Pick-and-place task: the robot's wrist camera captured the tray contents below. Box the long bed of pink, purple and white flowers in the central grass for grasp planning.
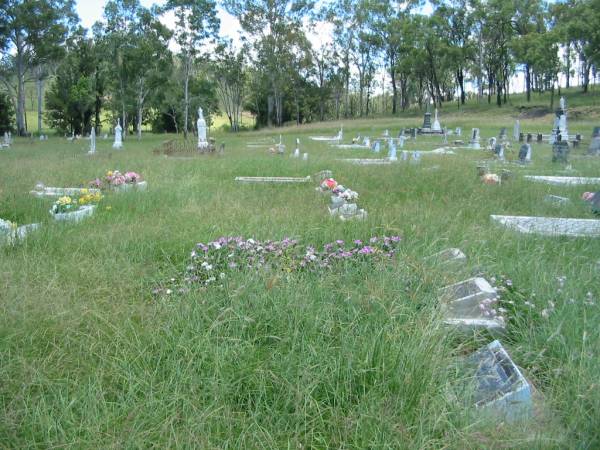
[154,236,401,294]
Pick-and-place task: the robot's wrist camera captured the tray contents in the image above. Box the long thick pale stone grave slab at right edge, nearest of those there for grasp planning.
[490,215,600,237]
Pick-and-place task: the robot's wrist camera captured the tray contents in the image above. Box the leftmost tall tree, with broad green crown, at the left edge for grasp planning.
[0,0,77,135]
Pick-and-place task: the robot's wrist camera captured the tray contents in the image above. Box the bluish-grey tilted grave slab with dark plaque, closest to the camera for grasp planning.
[461,340,533,422]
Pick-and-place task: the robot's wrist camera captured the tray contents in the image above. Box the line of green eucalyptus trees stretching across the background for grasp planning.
[0,0,600,136]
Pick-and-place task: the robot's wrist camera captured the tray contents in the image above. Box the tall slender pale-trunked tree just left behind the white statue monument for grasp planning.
[163,0,219,139]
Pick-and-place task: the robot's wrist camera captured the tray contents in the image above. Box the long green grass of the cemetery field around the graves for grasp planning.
[0,93,600,449]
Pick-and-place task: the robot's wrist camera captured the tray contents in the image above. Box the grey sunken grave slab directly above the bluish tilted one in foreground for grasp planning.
[440,277,505,331]
